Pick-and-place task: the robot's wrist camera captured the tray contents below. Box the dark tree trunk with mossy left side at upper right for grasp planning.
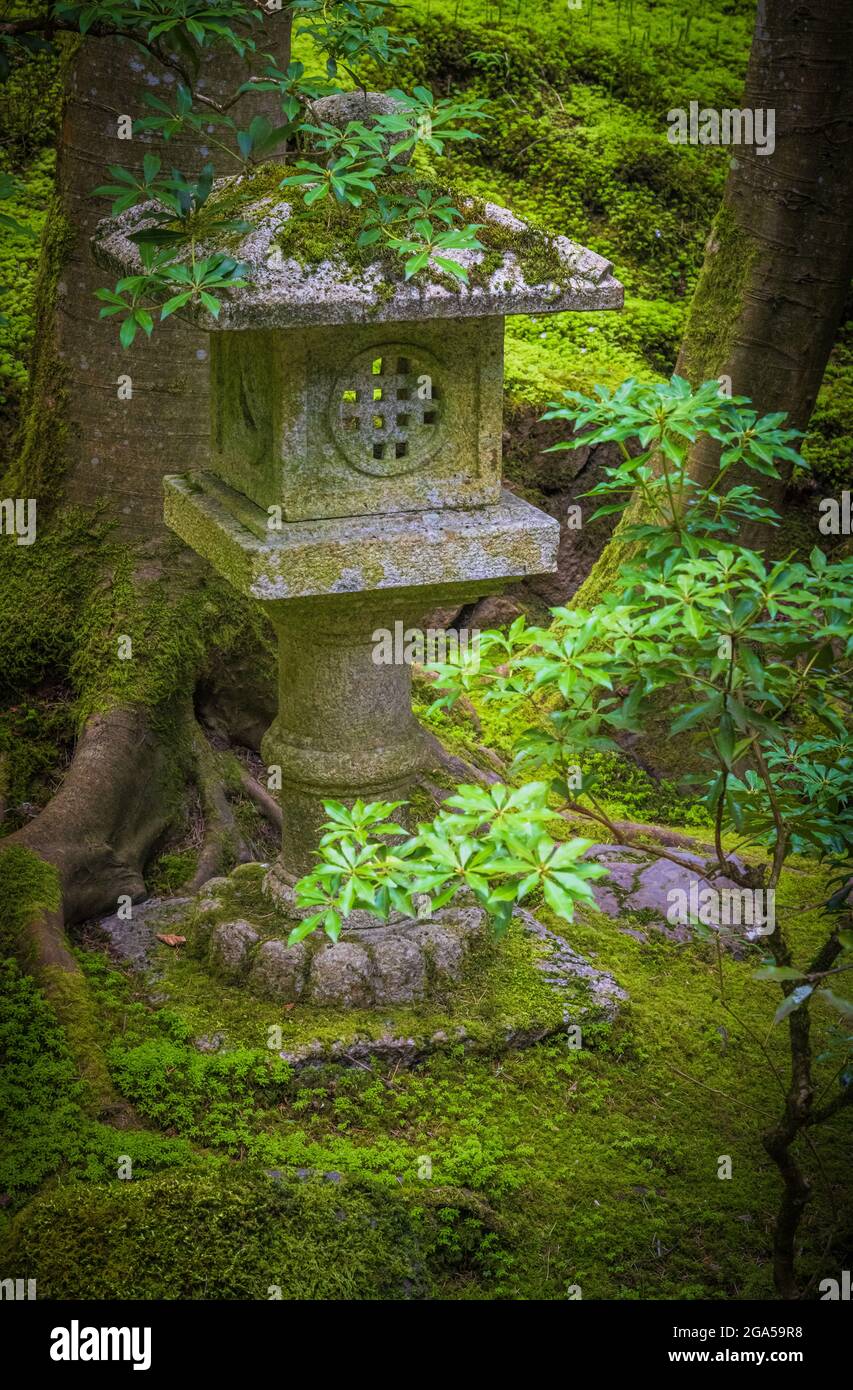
[675,0,853,507]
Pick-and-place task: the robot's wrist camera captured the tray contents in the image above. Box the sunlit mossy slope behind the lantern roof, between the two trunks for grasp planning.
[376,12,753,406]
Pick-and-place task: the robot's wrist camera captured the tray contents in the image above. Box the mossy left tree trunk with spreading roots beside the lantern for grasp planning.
[0,11,292,1089]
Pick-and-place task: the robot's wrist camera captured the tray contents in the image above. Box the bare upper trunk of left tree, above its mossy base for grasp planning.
[7,11,292,539]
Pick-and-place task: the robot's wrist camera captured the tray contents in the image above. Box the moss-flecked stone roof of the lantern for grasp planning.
[93,165,622,329]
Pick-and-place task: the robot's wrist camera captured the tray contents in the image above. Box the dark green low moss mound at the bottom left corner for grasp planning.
[4,1169,497,1301]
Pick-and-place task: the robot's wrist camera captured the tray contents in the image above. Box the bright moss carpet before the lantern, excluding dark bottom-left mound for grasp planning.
[28,863,849,1300]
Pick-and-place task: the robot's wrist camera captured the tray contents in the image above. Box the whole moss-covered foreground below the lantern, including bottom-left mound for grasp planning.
[0,839,852,1300]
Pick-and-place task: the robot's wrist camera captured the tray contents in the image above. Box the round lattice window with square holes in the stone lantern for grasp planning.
[340,356,440,461]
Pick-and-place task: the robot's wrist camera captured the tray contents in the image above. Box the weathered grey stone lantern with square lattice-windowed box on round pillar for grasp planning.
[94,200,622,900]
